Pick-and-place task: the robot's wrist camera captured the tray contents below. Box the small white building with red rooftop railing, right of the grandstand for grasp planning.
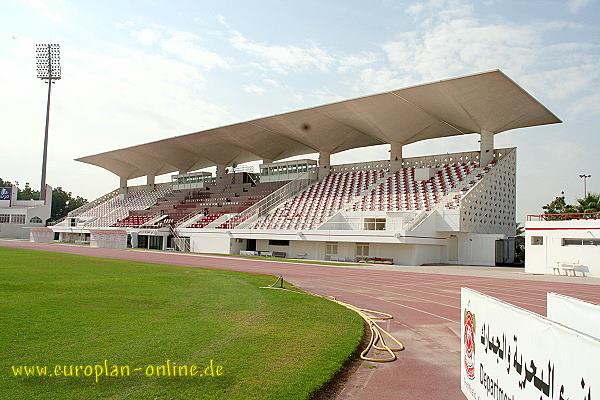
[525,213,600,277]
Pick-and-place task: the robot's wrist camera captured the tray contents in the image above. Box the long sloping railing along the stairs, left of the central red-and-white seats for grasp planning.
[221,172,314,229]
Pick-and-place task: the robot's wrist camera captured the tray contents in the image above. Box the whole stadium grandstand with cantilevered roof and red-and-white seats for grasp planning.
[44,70,561,265]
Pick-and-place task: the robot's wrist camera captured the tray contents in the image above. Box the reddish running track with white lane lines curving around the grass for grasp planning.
[0,240,600,400]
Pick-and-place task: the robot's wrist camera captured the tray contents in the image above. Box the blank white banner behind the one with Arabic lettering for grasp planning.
[546,293,600,340]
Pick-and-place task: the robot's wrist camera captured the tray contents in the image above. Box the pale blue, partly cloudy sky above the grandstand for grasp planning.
[0,0,600,221]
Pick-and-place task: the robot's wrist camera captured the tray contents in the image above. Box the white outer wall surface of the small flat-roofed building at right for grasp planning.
[525,220,600,276]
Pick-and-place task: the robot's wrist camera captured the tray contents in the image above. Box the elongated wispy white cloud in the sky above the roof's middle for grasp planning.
[229,30,334,74]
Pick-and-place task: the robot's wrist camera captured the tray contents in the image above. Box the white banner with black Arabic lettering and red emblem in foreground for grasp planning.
[460,288,600,400]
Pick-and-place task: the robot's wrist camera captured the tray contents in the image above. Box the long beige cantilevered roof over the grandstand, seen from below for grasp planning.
[77,70,561,179]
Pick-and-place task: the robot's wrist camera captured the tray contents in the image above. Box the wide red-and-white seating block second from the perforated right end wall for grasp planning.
[352,162,476,211]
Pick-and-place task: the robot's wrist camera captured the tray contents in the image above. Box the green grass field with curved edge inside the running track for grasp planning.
[0,248,363,399]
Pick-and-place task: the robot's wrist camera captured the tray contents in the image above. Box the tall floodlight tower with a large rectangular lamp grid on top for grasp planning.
[35,43,60,200]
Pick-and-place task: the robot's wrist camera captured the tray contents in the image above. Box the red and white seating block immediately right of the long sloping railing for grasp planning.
[254,170,385,229]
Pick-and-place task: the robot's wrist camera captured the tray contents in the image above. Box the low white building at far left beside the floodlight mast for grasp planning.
[0,185,52,239]
